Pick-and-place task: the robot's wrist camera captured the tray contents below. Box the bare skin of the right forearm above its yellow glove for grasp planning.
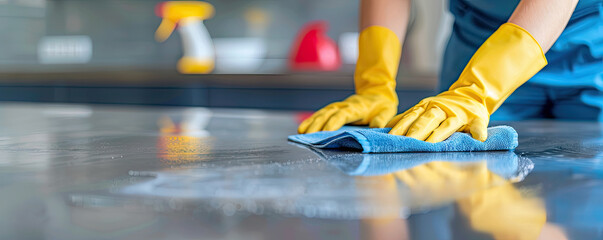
[509,0,578,53]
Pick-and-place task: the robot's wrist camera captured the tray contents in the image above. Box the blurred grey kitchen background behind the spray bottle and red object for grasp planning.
[0,0,452,110]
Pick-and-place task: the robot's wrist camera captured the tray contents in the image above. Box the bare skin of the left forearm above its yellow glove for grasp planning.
[360,0,410,41]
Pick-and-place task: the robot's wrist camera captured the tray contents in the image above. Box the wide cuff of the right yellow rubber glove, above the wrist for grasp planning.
[449,23,547,114]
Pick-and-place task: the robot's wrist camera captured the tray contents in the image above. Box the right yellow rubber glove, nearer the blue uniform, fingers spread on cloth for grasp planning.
[387,23,547,142]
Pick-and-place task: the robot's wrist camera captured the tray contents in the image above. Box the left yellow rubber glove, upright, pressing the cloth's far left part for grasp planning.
[297,26,402,133]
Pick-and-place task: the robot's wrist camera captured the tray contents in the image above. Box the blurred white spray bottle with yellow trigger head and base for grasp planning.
[155,1,215,74]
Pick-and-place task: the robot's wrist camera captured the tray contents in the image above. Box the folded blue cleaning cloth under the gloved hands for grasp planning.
[289,126,517,153]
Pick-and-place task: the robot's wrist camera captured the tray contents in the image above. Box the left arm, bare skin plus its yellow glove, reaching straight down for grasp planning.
[297,0,410,133]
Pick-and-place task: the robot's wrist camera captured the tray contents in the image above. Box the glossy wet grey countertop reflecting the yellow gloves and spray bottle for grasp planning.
[0,103,603,239]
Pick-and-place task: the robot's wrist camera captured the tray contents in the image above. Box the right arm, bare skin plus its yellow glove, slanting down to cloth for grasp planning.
[386,0,577,142]
